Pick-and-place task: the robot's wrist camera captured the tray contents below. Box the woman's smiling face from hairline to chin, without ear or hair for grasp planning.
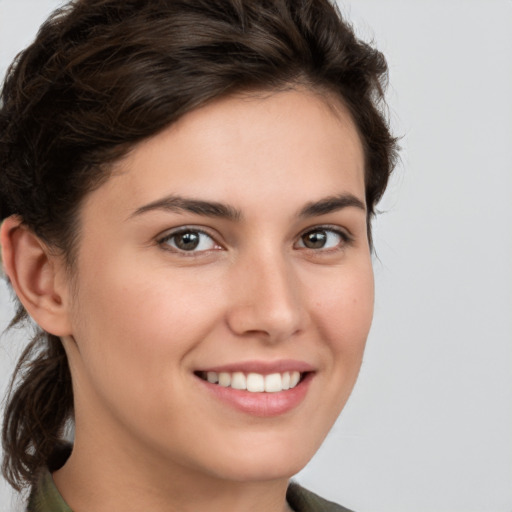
[65,91,373,481]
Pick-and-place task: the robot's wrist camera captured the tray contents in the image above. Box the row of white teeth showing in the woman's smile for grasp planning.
[201,371,301,393]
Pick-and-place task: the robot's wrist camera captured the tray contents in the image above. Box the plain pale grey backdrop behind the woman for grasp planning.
[0,0,512,512]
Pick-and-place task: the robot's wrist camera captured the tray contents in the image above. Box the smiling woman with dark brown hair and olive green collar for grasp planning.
[0,0,395,512]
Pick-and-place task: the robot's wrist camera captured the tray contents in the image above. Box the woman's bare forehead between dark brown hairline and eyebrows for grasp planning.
[84,90,364,220]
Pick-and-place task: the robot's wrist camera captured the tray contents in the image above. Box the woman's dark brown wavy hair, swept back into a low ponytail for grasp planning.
[0,0,396,489]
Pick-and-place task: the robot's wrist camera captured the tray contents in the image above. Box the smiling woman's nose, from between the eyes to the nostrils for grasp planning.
[227,249,308,343]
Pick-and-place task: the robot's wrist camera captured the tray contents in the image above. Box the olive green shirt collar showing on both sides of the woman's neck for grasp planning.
[27,470,350,512]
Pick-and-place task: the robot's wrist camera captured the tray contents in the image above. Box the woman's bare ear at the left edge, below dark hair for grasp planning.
[0,215,71,336]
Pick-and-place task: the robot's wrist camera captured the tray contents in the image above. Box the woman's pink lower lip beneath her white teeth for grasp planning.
[197,372,314,417]
